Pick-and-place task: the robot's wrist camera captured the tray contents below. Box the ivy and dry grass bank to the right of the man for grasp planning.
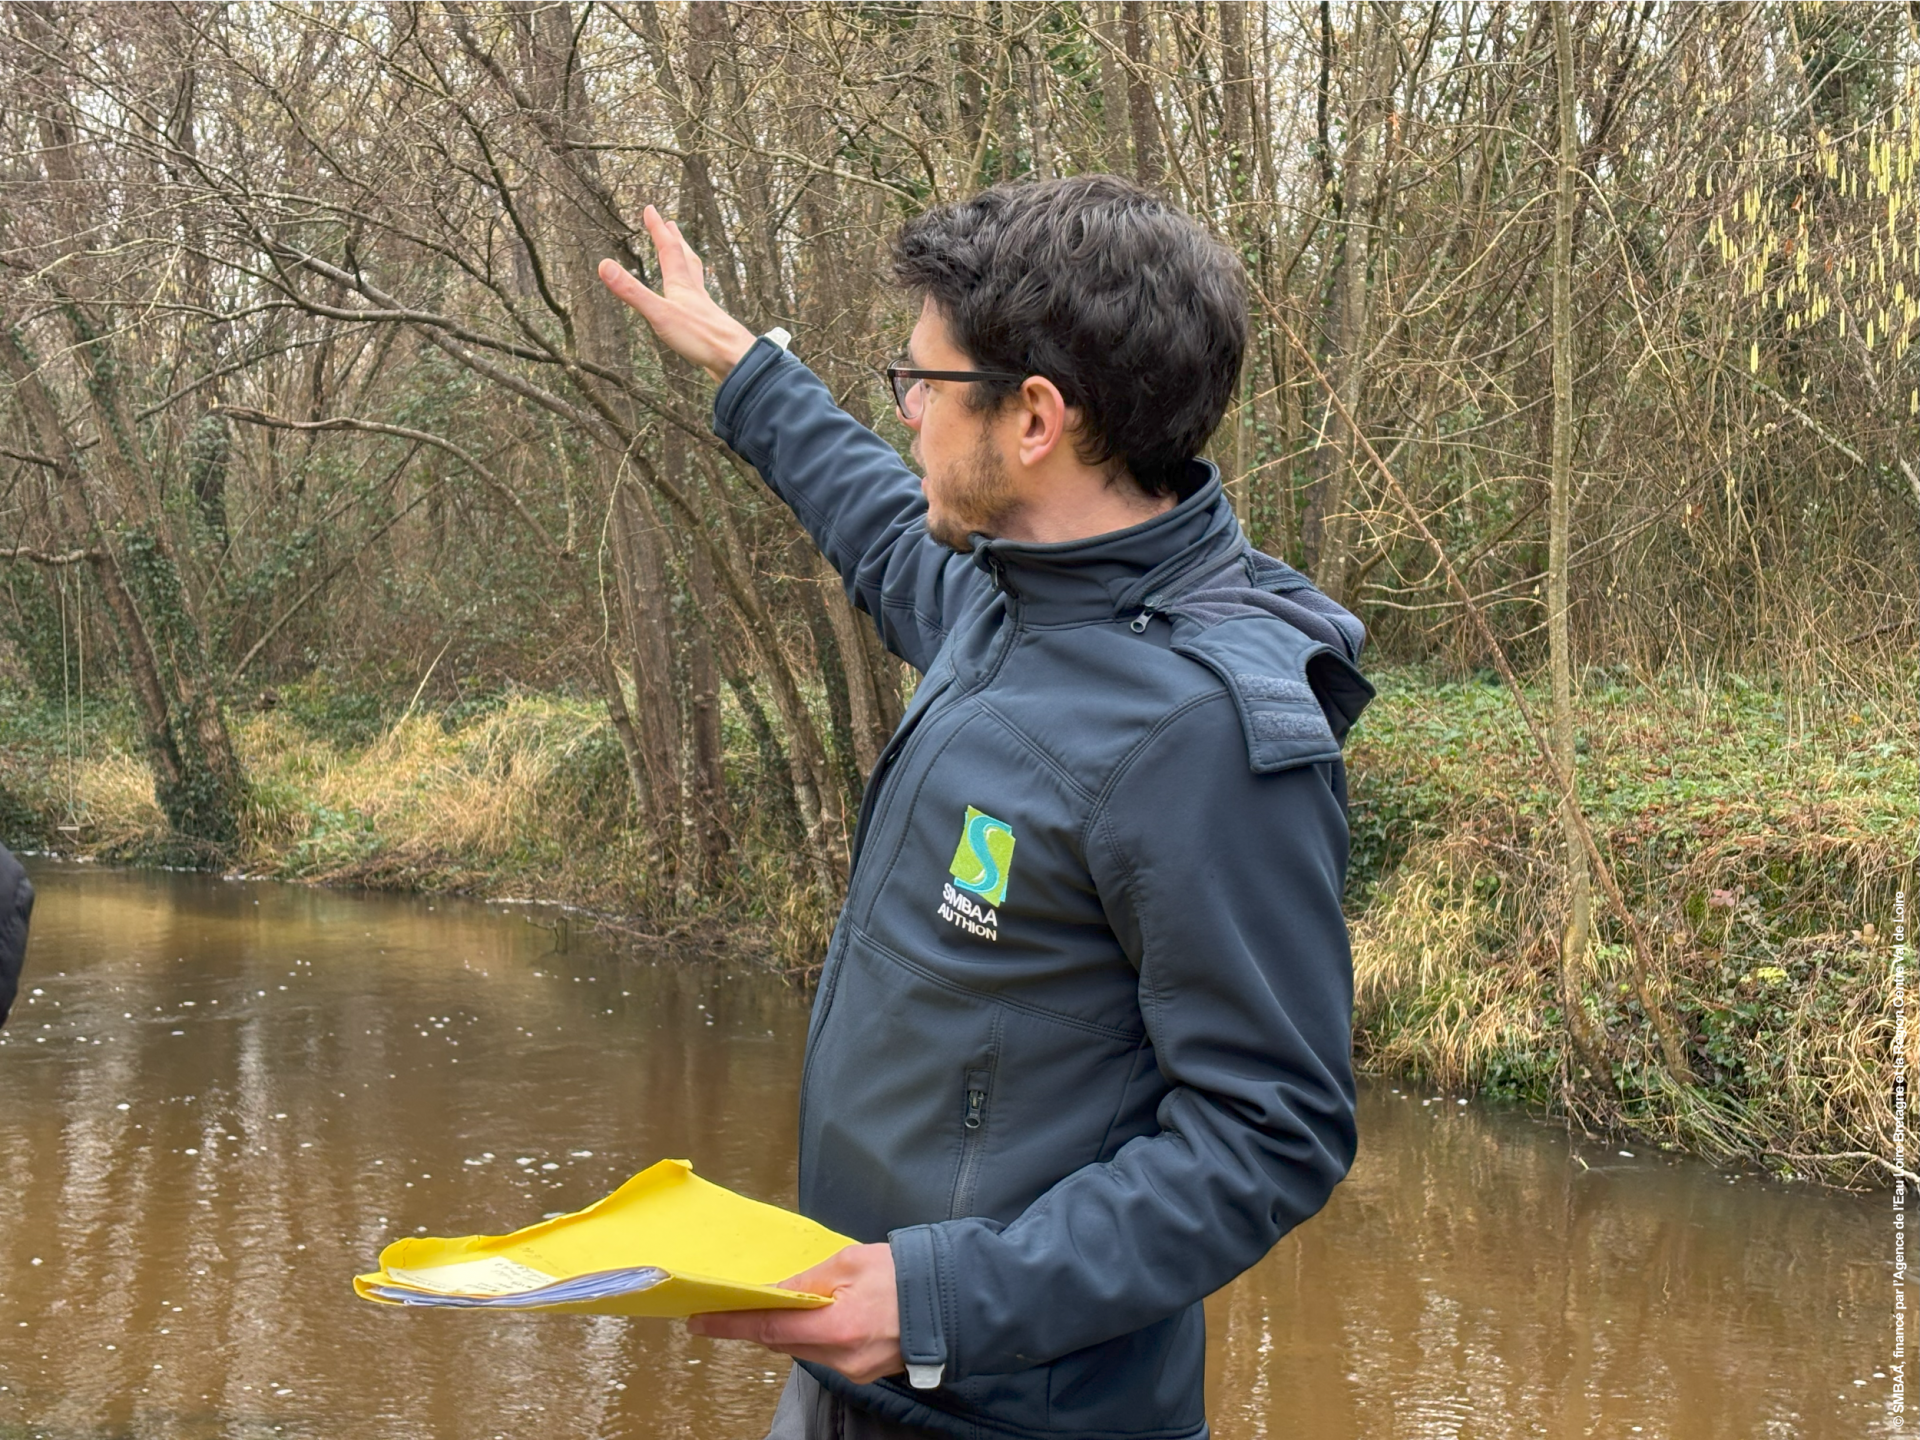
[1350,670,1920,1183]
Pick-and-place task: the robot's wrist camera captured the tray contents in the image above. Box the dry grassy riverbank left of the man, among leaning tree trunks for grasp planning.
[0,684,822,964]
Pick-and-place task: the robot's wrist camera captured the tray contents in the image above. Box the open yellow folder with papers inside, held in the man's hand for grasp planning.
[353,1160,852,1317]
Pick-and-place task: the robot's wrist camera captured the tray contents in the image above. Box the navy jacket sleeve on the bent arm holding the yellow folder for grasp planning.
[891,693,1356,1380]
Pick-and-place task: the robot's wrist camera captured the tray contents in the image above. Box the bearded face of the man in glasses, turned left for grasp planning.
[906,300,1023,553]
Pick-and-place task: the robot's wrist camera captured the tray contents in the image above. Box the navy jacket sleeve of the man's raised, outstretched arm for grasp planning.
[714,340,987,670]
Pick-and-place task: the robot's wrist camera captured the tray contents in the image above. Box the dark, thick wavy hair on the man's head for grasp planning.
[893,175,1246,497]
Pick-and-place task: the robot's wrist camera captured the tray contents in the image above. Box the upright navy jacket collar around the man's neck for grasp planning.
[972,461,1246,624]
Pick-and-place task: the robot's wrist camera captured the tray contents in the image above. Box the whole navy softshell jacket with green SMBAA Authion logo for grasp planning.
[714,340,1373,1440]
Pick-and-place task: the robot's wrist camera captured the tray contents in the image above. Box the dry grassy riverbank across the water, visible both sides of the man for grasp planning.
[0,670,1920,1185]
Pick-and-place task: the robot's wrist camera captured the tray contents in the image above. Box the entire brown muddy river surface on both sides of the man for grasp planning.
[0,864,1907,1440]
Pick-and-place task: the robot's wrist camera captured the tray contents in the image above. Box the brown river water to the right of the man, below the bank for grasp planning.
[1210,1085,1907,1440]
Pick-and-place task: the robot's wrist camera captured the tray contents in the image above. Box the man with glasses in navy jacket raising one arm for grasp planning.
[601,177,1373,1440]
